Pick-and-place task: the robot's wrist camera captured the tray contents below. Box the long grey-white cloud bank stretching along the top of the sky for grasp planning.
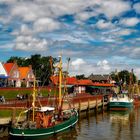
[5,0,131,22]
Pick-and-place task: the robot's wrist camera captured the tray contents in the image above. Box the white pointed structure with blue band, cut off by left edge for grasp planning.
[0,62,8,87]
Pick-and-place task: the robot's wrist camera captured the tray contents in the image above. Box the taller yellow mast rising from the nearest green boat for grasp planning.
[58,56,62,107]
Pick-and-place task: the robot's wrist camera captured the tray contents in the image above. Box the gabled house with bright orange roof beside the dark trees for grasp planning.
[18,65,35,87]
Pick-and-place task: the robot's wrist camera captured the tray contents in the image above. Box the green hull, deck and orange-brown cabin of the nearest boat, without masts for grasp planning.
[10,107,78,139]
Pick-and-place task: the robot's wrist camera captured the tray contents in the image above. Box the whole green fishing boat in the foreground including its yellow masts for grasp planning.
[10,57,78,139]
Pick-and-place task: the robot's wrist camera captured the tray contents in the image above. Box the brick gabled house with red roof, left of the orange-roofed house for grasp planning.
[3,62,21,87]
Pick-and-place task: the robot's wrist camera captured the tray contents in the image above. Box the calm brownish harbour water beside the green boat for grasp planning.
[0,108,140,140]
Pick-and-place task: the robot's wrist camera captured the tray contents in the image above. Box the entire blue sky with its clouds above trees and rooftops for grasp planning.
[0,0,140,78]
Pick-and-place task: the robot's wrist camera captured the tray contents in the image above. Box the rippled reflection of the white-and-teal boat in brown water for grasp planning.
[110,110,135,140]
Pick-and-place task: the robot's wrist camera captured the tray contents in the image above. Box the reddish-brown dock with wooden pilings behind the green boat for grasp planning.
[0,94,108,125]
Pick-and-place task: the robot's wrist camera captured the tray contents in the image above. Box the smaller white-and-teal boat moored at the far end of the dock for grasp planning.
[109,93,133,110]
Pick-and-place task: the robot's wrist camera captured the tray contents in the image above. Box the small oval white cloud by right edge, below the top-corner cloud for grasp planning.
[120,17,140,26]
